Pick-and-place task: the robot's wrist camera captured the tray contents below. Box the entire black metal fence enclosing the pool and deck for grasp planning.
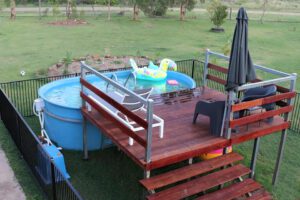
[0,59,300,199]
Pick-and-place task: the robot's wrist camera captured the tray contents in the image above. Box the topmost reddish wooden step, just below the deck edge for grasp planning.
[140,153,243,190]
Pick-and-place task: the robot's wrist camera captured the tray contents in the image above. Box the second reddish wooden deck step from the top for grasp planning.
[147,164,251,200]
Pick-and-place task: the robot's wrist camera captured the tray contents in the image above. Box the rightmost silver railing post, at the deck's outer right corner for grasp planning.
[272,73,297,185]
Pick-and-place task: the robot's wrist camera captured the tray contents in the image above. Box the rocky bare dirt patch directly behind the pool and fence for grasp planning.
[47,55,149,76]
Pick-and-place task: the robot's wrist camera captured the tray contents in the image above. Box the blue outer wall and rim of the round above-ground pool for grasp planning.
[38,70,196,150]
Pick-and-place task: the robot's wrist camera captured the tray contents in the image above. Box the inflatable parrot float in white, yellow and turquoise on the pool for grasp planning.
[130,58,177,81]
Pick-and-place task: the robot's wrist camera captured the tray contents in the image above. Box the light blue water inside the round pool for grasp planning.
[45,71,191,108]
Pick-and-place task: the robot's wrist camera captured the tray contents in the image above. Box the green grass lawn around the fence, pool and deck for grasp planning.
[0,13,300,200]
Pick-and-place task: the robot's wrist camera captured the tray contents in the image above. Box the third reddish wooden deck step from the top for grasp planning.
[196,179,262,200]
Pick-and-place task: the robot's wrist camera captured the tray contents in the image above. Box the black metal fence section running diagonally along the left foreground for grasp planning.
[0,89,82,200]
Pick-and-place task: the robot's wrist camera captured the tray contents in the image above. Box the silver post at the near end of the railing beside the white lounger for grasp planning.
[145,99,153,163]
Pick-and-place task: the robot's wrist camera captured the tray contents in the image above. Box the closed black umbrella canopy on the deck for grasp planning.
[225,8,256,91]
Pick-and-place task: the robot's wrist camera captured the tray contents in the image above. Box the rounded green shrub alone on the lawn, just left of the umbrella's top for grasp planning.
[207,0,227,28]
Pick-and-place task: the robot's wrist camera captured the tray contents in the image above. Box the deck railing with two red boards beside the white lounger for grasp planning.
[80,62,153,163]
